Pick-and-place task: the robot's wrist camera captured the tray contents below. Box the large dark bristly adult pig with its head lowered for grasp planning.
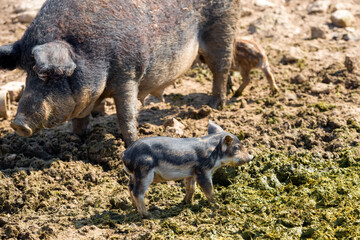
[0,0,240,145]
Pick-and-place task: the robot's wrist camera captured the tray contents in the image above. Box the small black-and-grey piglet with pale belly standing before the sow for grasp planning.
[122,121,253,217]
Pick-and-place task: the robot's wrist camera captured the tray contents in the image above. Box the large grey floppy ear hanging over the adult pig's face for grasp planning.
[32,41,76,80]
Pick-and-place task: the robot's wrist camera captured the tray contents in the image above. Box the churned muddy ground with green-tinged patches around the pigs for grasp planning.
[0,0,360,239]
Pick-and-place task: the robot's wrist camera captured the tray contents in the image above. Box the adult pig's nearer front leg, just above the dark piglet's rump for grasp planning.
[114,80,138,147]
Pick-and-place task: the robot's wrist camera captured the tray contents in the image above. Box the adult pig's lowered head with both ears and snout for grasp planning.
[0,41,100,136]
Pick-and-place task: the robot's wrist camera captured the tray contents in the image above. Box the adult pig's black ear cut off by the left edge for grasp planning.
[0,43,20,70]
